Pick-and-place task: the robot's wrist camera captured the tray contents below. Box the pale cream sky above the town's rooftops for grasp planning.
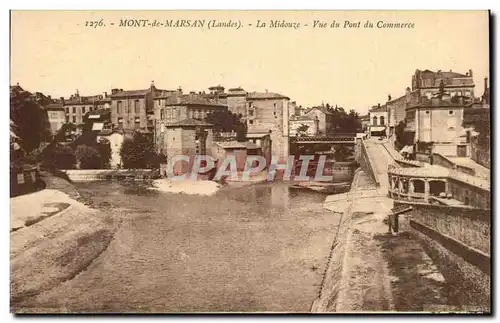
[10,11,489,113]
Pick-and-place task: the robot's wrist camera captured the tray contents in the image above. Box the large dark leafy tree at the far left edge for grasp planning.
[10,87,50,152]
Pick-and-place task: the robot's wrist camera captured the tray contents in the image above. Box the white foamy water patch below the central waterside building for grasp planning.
[146,178,221,196]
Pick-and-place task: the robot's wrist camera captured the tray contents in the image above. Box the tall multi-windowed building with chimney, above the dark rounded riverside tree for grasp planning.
[111,83,165,133]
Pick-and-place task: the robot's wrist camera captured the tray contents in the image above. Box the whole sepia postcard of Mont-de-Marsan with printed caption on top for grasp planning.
[10,10,492,314]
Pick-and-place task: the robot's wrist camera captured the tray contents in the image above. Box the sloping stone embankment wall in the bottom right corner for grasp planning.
[394,201,491,310]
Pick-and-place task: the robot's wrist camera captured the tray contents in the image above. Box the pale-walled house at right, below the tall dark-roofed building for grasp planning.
[406,96,471,161]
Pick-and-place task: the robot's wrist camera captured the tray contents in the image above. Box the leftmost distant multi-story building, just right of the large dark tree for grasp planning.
[60,90,111,125]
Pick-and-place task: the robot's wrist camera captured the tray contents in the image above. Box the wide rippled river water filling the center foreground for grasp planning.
[29,182,346,313]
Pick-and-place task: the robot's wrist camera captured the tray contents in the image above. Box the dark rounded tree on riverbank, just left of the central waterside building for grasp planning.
[120,132,160,169]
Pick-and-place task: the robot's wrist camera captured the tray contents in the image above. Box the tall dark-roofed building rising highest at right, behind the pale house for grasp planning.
[412,70,475,99]
